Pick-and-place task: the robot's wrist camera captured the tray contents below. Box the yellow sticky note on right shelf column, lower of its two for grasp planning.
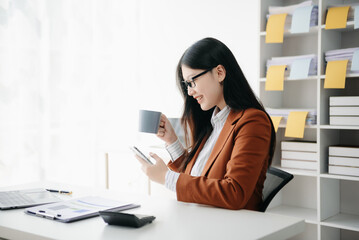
[324,60,348,88]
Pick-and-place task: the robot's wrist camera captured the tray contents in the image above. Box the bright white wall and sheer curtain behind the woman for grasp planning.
[0,0,259,190]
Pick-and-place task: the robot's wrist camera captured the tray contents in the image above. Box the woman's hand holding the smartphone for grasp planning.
[135,153,168,184]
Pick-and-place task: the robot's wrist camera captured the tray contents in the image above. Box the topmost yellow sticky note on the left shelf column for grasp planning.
[266,13,287,43]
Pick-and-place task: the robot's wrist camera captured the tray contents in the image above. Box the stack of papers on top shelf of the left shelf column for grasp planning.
[267,1,318,30]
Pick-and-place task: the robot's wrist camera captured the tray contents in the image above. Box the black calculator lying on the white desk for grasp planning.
[100,211,156,228]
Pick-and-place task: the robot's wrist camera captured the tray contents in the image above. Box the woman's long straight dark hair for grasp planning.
[177,38,276,170]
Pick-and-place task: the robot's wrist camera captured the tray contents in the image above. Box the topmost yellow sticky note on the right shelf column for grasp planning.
[325,6,350,29]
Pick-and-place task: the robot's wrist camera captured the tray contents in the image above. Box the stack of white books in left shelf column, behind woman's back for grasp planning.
[281,141,318,170]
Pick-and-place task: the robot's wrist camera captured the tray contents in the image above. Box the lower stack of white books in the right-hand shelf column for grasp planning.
[328,146,359,176]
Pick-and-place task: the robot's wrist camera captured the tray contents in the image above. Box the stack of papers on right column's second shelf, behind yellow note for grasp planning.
[325,47,359,73]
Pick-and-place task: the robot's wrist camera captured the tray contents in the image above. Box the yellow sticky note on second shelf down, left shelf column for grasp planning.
[265,65,286,91]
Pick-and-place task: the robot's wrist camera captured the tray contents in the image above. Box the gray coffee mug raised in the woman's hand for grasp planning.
[138,110,161,134]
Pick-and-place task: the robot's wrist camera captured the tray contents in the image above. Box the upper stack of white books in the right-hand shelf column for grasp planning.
[329,96,359,126]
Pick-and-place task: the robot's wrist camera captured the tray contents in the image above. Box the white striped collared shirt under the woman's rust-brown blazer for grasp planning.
[165,106,231,191]
